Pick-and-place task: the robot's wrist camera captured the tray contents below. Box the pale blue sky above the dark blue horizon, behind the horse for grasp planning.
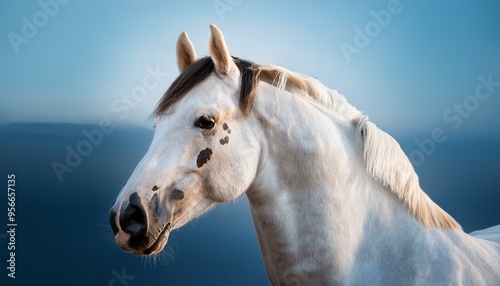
[0,0,500,139]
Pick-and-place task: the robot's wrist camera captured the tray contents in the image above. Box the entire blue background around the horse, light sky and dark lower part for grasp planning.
[0,0,500,285]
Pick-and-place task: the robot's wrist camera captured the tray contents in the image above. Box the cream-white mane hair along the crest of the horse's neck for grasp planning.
[257,65,460,228]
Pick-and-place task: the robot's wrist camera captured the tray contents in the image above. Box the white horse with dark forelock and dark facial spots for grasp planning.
[109,25,500,285]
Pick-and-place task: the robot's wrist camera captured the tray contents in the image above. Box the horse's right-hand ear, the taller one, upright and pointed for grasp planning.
[210,24,236,75]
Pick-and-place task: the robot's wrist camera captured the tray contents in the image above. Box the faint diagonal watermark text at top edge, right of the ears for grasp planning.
[339,0,403,63]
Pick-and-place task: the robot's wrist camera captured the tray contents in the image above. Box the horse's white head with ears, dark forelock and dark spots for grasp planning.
[109,25,260,255]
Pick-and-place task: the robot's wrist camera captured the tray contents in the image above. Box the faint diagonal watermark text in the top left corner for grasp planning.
[7,0,70,54]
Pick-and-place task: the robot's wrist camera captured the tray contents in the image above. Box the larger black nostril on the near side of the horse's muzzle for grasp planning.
[120,193,148,238]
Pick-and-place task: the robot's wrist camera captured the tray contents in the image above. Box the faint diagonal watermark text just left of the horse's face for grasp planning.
[51,66,168,183]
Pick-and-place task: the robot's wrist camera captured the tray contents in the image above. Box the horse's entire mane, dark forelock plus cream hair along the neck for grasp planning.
[154,54,460,228]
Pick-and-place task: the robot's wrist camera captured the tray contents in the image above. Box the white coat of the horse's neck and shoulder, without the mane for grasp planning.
[247,81,500,285]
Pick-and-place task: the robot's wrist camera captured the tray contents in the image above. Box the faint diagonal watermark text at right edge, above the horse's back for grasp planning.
[409,74,500,166]
